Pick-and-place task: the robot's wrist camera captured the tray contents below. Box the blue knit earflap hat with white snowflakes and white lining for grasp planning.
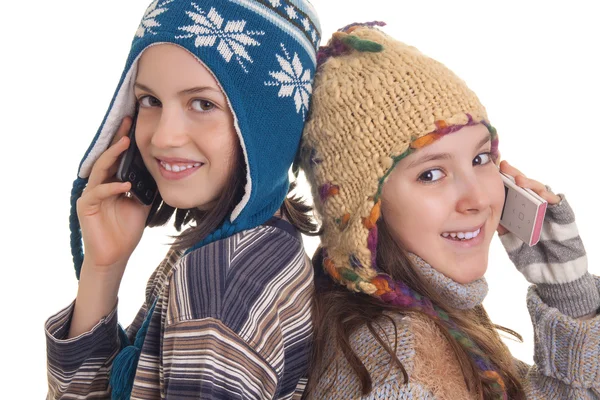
[70,0,321,278]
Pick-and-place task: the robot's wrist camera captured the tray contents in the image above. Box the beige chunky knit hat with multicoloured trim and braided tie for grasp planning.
[300,22,504,398]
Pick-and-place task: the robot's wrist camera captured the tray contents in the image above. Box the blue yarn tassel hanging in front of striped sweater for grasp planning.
[109,299,158,400]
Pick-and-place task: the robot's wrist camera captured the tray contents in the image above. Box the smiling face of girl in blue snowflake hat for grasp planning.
[135,44,241,210]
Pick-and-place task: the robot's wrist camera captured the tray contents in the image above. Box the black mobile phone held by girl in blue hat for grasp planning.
[117,105,158,205]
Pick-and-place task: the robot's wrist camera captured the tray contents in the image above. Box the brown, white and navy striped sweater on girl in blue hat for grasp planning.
[46,218,313,400]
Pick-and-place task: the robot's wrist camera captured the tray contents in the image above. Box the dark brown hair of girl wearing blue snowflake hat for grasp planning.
[146,144,317,245]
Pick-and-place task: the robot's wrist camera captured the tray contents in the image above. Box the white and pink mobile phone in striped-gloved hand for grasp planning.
[500,172,548,246]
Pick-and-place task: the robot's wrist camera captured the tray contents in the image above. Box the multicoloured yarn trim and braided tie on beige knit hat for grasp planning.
[306,21,507,400]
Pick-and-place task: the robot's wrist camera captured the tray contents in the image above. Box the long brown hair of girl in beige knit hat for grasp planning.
[305,218,525,399]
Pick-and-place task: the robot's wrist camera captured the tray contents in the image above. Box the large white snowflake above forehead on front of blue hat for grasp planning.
[175,3,265,73]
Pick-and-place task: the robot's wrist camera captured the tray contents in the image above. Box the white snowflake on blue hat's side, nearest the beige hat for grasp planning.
[265,43,312,120]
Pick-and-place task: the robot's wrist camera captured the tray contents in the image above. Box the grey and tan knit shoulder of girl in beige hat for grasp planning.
[317,313,470,399]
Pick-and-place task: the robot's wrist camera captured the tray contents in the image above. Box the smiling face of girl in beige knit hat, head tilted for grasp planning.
[381,124,504,283]
